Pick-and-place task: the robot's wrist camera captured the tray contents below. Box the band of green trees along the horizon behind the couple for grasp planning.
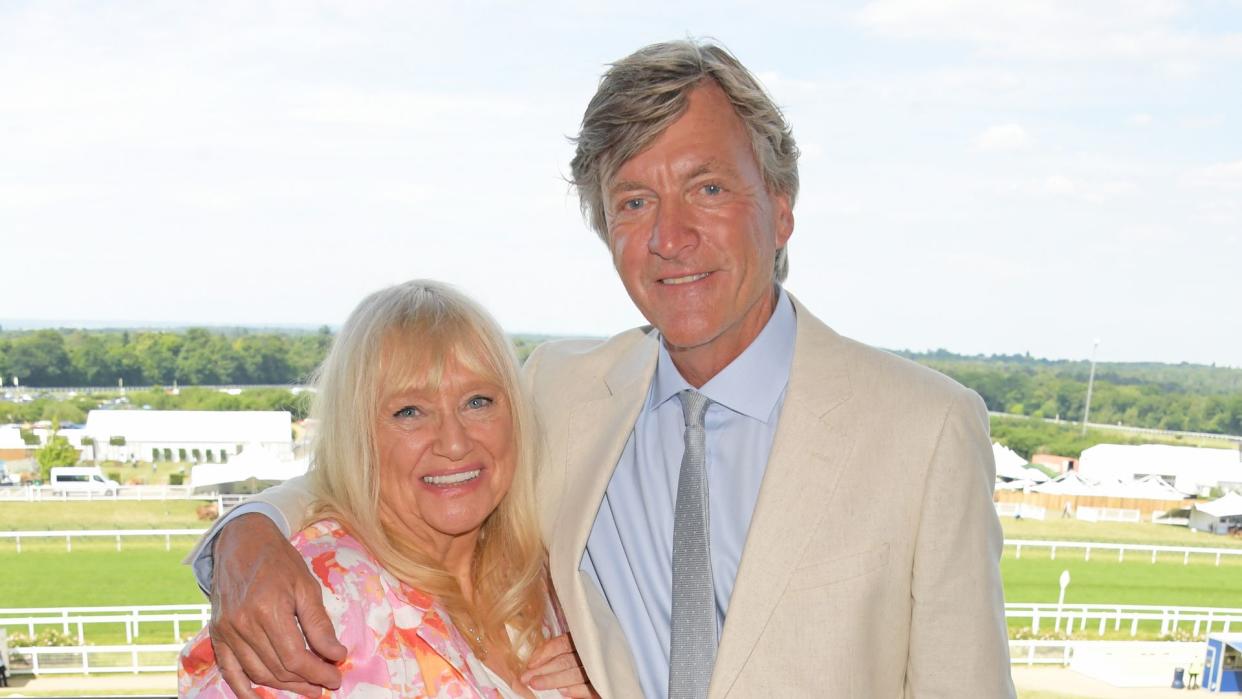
[0,327,1242,435]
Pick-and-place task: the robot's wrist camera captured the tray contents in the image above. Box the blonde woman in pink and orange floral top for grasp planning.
[179,281,586,698]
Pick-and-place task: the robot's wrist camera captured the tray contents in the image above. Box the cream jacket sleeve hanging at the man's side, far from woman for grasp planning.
[905,391,1015,698]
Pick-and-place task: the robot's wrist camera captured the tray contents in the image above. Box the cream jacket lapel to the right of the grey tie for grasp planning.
[710,299,853,697]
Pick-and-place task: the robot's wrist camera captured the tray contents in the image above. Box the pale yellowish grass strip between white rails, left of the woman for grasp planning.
[0,500,211,533]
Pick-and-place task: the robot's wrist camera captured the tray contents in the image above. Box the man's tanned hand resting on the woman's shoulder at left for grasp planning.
[211,514,345,699]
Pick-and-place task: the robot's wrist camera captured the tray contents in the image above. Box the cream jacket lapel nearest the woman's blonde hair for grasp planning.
[548,336,657,687]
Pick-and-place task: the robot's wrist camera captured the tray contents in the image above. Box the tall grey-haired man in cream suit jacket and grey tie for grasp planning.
[191,41,1013,698]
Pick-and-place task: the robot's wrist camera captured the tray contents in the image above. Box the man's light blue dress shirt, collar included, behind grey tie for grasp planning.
[581,289,797,699]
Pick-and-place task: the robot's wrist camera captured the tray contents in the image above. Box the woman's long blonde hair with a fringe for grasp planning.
[311,279,546,668]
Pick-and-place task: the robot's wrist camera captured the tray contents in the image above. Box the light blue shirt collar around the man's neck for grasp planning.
[647,287,797,422]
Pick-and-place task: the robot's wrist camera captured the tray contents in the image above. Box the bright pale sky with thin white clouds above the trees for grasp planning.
[0,0,1242,366]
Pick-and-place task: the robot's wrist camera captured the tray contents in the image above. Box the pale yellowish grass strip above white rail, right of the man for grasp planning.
[1001,516,1242,548]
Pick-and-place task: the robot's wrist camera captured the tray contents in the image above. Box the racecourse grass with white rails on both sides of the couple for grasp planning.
[0,500,1242,644]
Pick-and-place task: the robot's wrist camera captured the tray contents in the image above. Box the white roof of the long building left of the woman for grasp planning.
[86,410,293,444]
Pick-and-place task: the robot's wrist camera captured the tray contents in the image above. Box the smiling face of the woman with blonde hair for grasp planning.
[375,361,517,555]
